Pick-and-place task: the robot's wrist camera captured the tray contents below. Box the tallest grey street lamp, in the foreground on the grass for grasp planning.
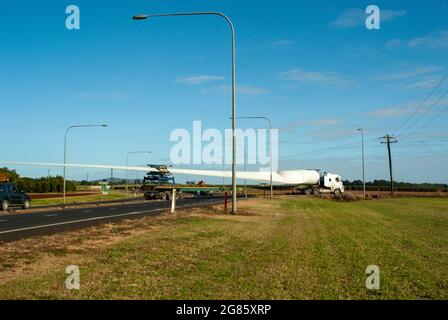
[132,12,237,214]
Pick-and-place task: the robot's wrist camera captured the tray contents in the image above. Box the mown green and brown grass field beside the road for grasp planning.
[0,197,448,299]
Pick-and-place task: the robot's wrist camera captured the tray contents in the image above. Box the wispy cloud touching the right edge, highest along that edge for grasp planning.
[386,30,448,49]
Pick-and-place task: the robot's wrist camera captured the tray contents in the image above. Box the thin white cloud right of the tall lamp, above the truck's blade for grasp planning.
[280,69,356,86]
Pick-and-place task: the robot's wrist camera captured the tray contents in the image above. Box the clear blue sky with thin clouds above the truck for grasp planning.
[0,0,448,183]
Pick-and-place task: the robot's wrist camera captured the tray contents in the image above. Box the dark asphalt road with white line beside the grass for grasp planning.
[0,197,230,242]
